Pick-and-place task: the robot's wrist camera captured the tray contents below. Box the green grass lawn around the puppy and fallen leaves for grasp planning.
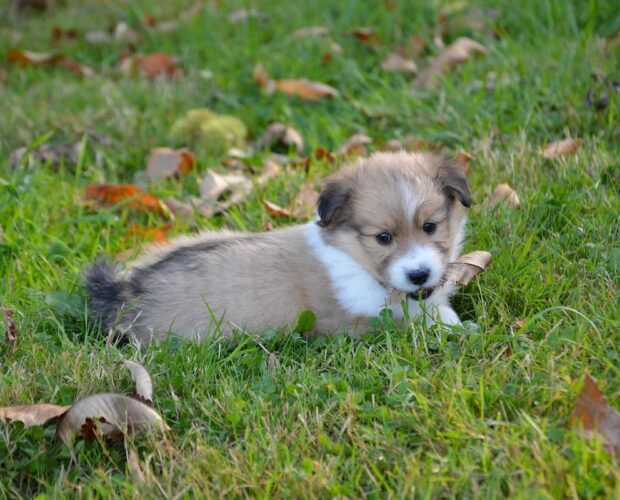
[0,0,620,498]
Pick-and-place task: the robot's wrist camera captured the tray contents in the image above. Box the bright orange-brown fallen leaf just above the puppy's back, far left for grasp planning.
[83,184,169,215]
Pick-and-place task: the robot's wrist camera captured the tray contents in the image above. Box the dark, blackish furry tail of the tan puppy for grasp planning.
[84,260,130,330]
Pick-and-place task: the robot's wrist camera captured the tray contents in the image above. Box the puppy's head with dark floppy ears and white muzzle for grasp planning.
[317,152,472,293]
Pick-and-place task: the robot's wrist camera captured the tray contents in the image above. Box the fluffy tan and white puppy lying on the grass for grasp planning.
[86,152,472,341]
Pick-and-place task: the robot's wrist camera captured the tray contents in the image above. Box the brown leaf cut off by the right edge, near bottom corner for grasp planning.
[571,372,620,455]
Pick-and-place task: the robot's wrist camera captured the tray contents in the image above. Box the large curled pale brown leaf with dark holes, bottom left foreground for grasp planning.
[56,393,167,444]
